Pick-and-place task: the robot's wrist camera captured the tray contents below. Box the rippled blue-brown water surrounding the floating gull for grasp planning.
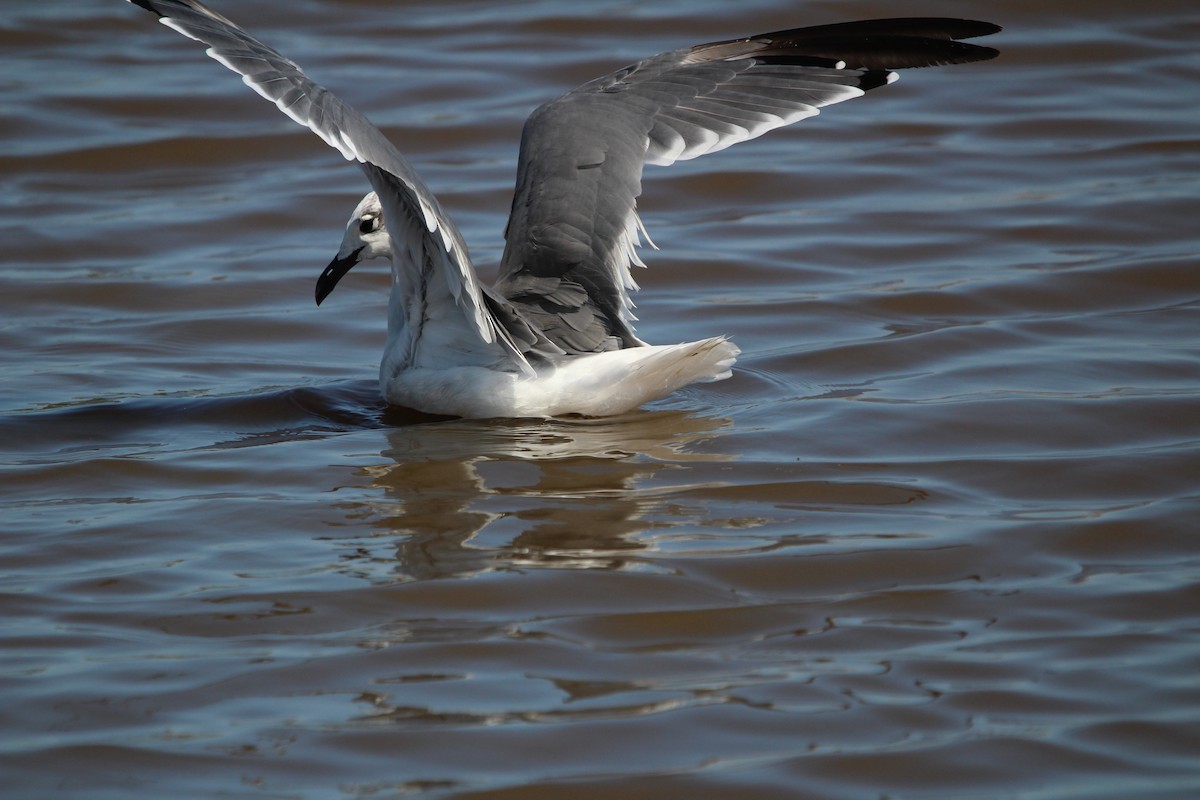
[0,0,1200,800]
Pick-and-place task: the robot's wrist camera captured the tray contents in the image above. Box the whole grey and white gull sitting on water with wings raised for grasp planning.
[130,0,1000,419]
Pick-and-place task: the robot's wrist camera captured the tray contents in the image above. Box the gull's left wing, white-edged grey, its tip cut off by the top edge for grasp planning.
[130,0,540,371]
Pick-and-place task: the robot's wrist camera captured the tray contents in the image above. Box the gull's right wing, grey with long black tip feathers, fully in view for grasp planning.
[494,18,1000,353]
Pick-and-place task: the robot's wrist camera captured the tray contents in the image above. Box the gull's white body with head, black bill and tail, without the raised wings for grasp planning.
[328,192,738,417]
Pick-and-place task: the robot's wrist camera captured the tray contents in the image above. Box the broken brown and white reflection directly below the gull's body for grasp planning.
[360,413,730,578]
